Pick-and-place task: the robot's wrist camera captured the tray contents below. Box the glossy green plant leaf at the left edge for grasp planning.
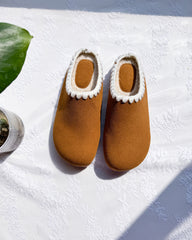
[0,23,33,93]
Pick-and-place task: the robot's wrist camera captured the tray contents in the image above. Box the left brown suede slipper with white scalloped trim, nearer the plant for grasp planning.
[53,50,103,167]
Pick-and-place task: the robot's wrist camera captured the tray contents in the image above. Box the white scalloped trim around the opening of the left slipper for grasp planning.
[66,49,103,99]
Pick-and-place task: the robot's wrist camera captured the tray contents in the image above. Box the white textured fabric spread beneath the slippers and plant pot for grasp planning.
[0,0,192,240]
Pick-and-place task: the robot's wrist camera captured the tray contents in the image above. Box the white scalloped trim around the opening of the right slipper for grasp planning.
[110,54,145,103]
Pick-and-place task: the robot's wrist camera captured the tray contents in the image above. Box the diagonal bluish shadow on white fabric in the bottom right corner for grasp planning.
[118,165,192,240]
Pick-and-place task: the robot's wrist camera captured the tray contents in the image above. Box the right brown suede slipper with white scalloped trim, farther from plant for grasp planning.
[103,54,150,171]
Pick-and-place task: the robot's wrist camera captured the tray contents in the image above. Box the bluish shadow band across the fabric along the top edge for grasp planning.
[0,0,192,17]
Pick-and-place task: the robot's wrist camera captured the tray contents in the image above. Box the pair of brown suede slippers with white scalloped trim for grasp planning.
[53,49,150,171]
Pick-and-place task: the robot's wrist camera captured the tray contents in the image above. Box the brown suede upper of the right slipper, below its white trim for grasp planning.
[103,88,150,171]
